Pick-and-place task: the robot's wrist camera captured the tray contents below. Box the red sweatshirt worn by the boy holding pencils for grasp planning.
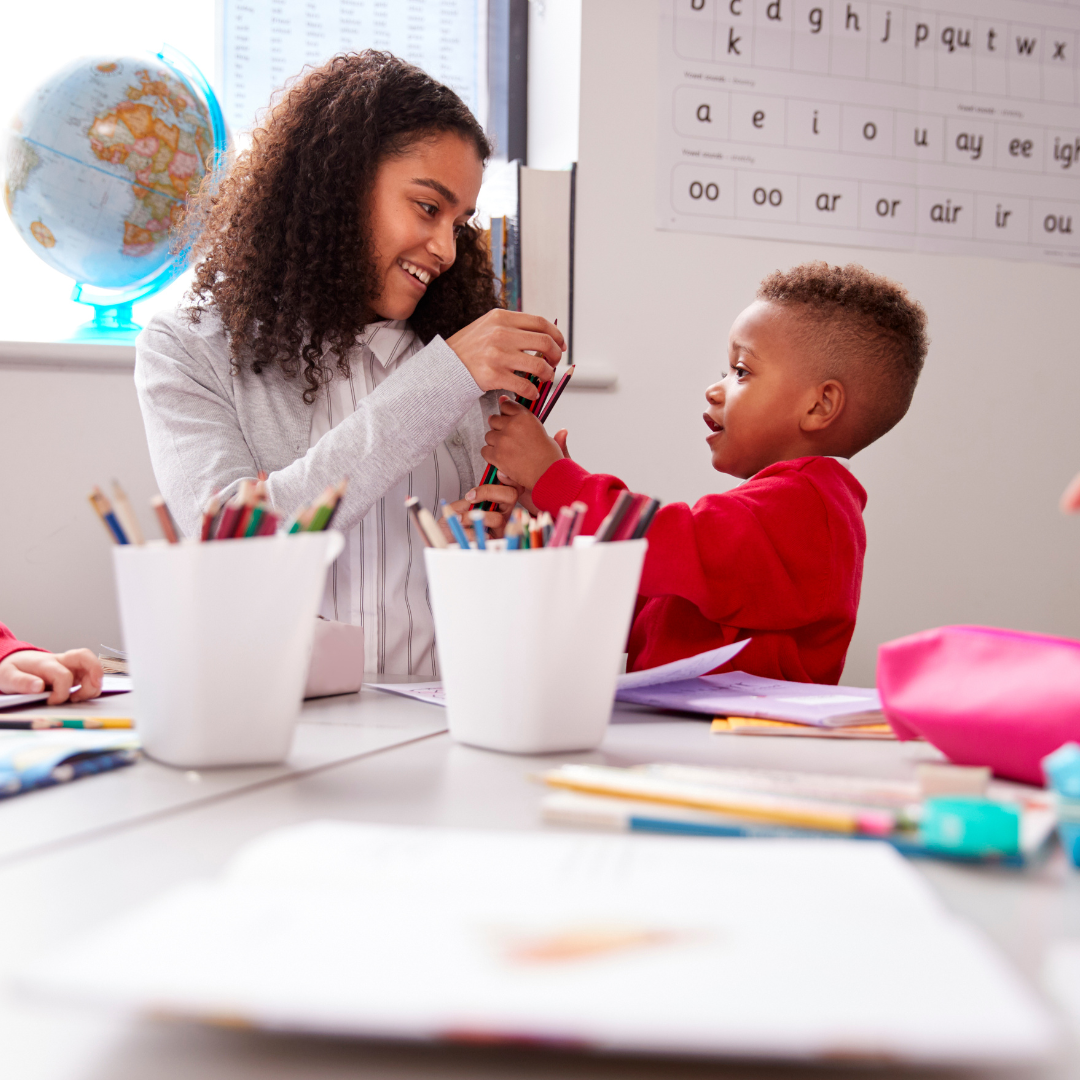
[532,457,866,683]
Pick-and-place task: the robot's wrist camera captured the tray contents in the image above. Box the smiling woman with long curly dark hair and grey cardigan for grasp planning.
[135,52,564,675]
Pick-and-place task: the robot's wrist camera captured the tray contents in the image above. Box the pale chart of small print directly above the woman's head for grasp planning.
[218,0,486,131]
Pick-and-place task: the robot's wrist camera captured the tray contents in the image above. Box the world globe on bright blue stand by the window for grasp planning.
[3,51,228,338]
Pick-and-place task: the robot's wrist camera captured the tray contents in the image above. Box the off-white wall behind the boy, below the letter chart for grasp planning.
[558,0,1080,685]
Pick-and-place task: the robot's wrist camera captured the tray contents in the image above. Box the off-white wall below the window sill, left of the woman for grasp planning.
[0,352,159,652]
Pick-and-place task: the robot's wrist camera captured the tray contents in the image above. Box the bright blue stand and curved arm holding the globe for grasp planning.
[69,45,229,345]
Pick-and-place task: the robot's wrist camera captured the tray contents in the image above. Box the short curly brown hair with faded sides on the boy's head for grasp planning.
[757,262,929,454]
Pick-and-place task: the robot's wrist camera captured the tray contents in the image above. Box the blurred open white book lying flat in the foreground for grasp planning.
[18,822,1053,1067]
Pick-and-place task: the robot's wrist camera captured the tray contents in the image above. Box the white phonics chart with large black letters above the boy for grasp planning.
[657,0,1080,264]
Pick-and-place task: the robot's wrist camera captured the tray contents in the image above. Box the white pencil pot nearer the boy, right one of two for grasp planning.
[424,538,646,754]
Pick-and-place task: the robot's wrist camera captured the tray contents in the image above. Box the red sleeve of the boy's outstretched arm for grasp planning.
[532,459,833,630]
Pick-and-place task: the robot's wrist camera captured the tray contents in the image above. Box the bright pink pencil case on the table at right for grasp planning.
[877,626,1080,786]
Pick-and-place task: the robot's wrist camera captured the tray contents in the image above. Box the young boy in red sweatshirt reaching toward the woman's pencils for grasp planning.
[479,262,927,683]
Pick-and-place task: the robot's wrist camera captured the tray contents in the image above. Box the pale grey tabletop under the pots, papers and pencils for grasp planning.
[0,691,1080,1080]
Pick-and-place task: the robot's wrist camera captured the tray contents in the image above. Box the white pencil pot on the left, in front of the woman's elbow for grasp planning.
[113,530,345,769]
